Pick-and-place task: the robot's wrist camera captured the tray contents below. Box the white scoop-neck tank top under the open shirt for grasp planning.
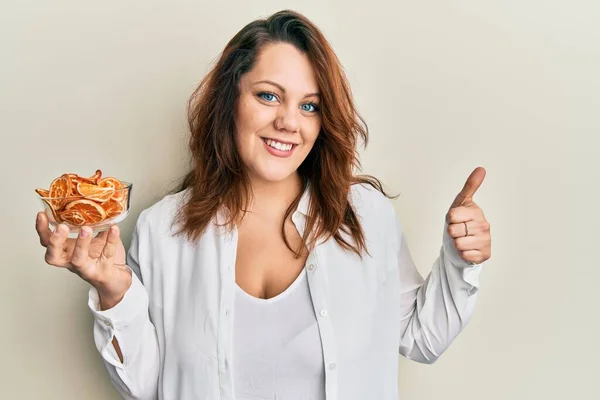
[232,269,325,400]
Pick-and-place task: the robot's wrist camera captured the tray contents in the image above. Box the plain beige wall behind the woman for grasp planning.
[0,0,600,400]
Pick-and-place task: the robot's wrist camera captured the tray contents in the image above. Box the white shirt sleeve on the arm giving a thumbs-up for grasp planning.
[396,219,482,364]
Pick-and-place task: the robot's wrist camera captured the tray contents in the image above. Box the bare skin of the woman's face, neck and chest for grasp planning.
[236,43,321,298]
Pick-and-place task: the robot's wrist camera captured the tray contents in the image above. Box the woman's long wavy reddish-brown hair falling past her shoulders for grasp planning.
[175,10,389,256]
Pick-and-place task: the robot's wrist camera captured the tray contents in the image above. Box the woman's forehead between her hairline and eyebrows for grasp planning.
[244,43,318,93]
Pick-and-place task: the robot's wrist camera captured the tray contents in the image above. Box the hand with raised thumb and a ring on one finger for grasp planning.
[446,167,492,264]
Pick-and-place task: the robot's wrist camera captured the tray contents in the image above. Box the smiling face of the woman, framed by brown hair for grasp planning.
[235,43,321,182]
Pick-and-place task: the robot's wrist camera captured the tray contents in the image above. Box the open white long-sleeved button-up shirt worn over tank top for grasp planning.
[89,185,481,400]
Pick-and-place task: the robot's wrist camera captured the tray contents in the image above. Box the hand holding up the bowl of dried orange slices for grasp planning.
[35,212,132,310]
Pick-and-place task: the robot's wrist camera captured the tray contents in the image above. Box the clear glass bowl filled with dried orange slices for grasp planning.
[36,181,132,238]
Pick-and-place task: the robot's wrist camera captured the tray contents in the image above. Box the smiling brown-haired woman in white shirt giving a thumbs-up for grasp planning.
[36,11,490,400]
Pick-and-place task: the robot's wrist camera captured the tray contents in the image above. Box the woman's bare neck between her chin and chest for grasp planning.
[250,173,302,219]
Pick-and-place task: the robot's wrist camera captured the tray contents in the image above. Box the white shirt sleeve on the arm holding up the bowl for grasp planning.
[88,220,159,400]
